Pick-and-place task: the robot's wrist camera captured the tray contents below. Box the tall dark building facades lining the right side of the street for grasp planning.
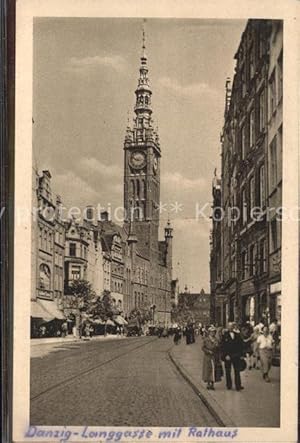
[211,20,282,324]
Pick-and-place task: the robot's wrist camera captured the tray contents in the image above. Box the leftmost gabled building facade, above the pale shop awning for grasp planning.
[31,170,65,336]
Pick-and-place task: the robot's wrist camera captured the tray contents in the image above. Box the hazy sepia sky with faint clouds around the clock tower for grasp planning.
[33,18,246,292]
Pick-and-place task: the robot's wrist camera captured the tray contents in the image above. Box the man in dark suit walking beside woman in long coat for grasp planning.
[221,323,244,391]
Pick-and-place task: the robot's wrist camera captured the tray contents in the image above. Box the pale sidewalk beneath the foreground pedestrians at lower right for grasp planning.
[169,337,280,427]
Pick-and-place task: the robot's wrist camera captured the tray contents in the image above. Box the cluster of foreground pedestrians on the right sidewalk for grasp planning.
[202,321,280,391]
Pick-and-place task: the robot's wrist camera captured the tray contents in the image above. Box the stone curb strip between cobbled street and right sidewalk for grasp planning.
[168,350,236,427]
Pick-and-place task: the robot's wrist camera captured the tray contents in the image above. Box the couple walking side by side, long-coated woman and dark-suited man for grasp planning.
[202,323,245,391]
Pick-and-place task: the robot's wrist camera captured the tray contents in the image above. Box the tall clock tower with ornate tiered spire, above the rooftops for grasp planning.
[124,23,161,258]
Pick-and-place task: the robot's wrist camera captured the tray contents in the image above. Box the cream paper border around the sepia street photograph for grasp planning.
[13,0,300,443]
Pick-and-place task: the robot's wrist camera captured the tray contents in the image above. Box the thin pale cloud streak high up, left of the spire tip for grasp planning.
[67,55,126,72]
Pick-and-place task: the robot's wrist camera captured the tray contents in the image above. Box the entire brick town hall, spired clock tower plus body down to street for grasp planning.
[124,33,173,323]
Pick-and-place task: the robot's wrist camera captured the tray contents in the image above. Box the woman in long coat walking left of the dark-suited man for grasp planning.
[202,326,222,390]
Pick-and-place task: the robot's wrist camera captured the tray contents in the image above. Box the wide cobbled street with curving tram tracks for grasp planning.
[30,337,218,426]
